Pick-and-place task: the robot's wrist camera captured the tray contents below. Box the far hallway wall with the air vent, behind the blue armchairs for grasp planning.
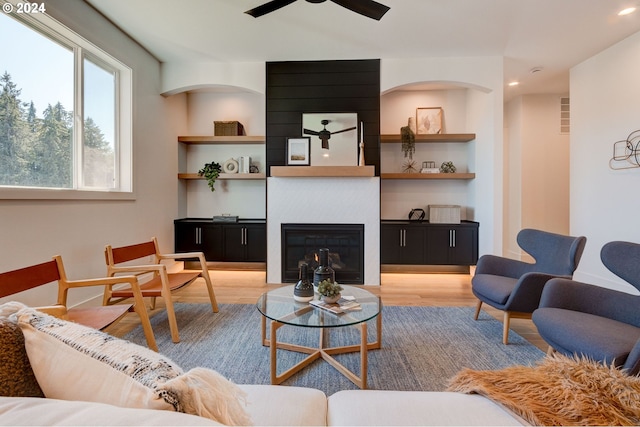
[504,95,569,258]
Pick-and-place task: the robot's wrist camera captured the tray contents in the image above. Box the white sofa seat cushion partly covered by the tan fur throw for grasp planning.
[327,390,524,426]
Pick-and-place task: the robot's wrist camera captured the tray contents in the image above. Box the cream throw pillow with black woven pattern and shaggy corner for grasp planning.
[0,306,250,425]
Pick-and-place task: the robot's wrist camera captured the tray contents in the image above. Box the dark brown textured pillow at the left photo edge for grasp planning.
[0,319,44,397]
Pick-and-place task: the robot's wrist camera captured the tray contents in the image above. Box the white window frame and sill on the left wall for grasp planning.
[0,0,135,200]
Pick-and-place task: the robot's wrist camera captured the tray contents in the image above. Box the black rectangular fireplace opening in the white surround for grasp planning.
[281,224,364,285]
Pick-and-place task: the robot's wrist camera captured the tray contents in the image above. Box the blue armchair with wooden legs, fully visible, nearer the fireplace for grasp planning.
[471,228,587,344]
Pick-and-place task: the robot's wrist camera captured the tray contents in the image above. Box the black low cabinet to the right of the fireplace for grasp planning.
[380,220,479,265]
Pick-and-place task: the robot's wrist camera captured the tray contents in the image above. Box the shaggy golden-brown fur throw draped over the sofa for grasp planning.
[448,354,640,425]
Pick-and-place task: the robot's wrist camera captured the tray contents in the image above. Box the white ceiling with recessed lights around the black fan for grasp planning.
[85,0,640,99]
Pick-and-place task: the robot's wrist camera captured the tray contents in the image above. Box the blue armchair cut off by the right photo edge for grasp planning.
[533,241,640,375]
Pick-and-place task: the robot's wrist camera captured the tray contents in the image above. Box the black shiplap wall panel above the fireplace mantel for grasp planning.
[266,59,380,176]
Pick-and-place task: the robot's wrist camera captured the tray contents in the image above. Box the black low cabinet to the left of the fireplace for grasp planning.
[174,218,267,262]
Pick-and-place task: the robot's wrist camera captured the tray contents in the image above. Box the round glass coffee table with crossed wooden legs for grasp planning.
[256,285,382,389]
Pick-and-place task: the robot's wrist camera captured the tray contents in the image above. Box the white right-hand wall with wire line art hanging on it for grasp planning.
[570,33,640,293]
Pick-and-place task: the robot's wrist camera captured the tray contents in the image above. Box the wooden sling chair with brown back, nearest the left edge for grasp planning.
[0,255,158,351]
